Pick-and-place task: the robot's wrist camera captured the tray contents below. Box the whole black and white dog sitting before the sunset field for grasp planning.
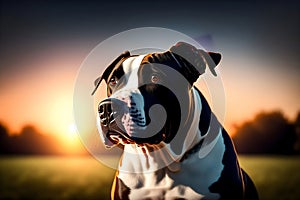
[92,42,258,200]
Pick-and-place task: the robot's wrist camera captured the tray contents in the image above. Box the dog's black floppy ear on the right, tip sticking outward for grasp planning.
[170,42,222,81]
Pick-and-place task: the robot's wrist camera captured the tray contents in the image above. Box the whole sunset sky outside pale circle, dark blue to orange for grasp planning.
[0,0,300,153]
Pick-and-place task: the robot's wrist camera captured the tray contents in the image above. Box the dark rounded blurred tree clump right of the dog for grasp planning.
[233,111,296,154]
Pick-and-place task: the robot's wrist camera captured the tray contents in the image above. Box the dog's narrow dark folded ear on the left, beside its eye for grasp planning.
[92,51,130,95]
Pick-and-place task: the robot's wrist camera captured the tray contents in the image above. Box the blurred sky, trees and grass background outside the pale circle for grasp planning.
[0,0,300,199]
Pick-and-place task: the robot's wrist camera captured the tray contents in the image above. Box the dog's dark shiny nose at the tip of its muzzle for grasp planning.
[98,99,120,127]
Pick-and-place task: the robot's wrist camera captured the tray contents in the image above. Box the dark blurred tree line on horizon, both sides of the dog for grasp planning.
[0,111,300,155]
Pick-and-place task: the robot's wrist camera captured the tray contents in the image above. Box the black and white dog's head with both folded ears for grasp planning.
[93,42,221,147]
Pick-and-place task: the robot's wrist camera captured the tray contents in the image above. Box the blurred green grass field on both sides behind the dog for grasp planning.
[0,156,300,200]
